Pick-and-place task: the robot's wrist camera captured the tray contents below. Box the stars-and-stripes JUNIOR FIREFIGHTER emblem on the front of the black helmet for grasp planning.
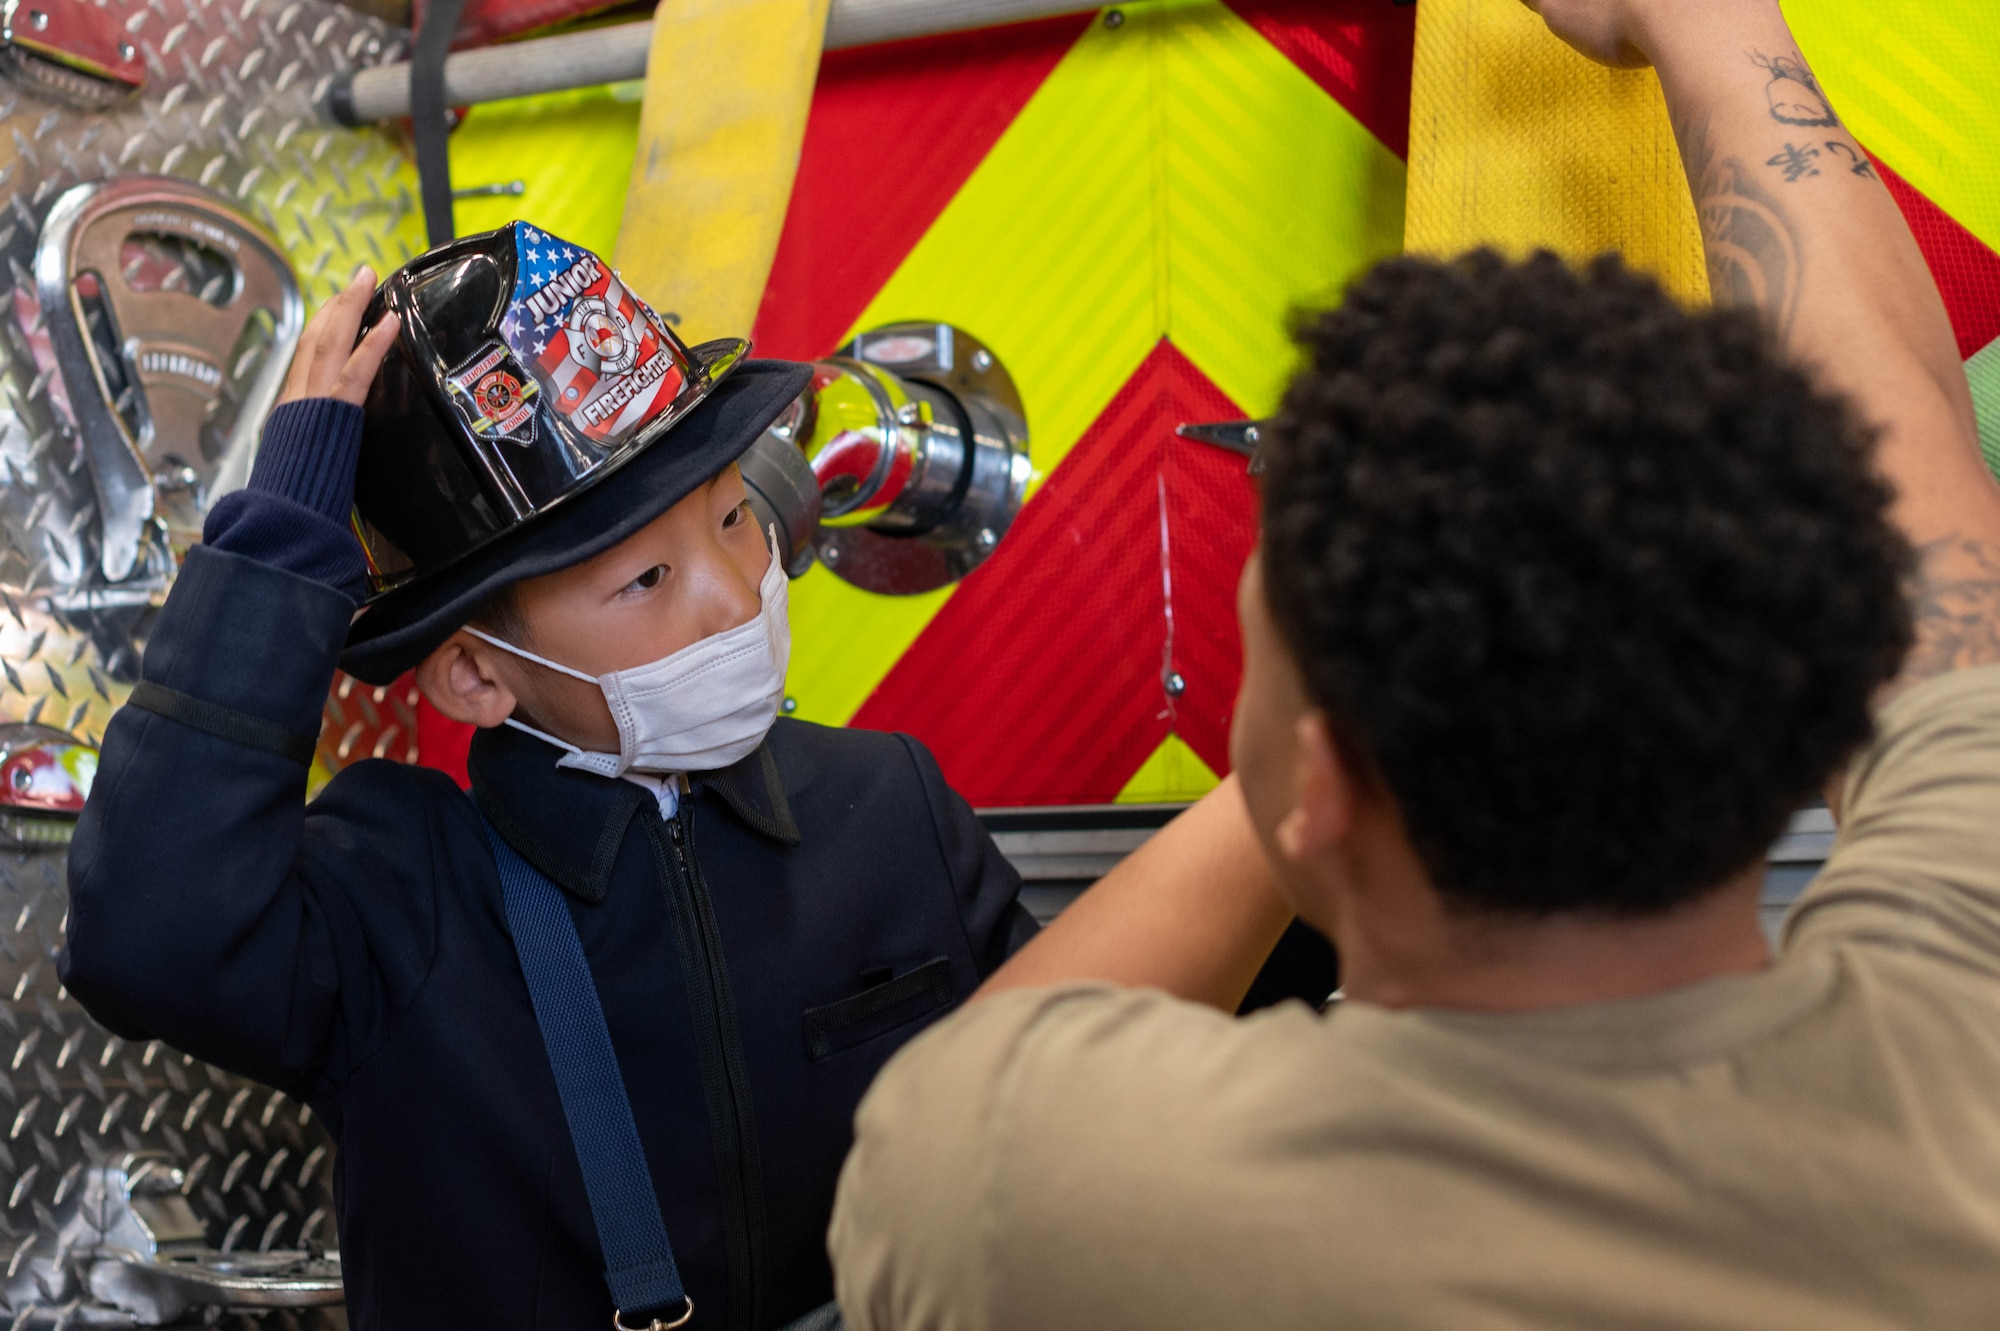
[500,222,688,448]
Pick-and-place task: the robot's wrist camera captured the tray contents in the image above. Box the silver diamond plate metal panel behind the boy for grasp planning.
[0,0,422,1327]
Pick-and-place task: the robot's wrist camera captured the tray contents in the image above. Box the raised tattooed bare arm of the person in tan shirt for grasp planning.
[1528,0,2000,685]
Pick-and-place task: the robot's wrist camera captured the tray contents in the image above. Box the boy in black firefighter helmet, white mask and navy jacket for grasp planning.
[62,224,1064,1329]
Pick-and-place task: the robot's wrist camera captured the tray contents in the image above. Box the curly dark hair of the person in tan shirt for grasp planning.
[1264,250,1912,917]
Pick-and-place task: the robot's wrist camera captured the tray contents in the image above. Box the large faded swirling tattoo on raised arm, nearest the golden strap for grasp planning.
[1674,116,1804,338]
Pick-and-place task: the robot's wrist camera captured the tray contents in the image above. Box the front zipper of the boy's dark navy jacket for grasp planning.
[662,801,764,1331]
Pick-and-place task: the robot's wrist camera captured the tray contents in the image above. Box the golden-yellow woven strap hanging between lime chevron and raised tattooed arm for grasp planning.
[1406,0,1708,302]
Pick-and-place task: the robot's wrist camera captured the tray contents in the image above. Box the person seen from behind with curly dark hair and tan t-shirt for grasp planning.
[832,0,2000,1331]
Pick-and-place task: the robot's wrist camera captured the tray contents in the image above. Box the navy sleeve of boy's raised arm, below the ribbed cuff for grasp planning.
[60,546,446,1097]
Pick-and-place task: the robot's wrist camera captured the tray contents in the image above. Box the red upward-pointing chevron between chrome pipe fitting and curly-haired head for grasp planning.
[852,340,1256,805]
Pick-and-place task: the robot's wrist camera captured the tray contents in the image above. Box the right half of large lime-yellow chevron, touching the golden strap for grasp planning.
[1156,4,1406,416]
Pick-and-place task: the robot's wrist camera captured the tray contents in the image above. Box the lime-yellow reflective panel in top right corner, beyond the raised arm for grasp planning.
[1784,0,2000,248]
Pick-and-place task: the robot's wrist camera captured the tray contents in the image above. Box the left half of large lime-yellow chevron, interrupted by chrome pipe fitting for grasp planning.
[790,10,1164,725]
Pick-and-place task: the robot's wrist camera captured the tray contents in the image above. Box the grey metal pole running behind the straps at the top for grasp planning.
[328,0,1096,124]
